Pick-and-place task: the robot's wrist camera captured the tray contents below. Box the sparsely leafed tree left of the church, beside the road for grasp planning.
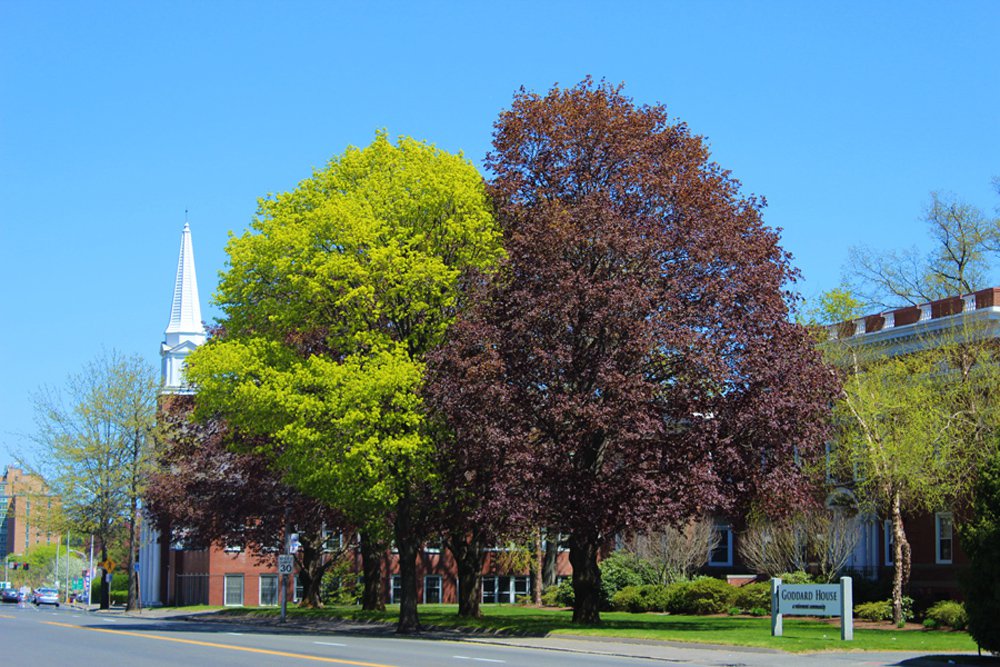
[28,351,159,609]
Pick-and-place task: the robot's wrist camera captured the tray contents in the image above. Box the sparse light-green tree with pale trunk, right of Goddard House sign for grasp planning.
[827,329,1000,623]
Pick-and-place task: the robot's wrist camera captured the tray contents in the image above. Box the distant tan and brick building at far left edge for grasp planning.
[0,466,59,558]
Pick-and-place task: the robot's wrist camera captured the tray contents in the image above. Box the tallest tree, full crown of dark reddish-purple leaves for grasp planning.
[432,79,836,623]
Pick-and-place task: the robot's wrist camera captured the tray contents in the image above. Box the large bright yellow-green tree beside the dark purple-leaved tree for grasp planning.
[188,132,501,632]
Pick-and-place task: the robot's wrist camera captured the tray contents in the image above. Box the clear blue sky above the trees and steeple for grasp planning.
[0,0,1000,465]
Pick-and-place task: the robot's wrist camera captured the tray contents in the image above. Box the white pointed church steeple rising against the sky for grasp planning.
[160,222,206,392]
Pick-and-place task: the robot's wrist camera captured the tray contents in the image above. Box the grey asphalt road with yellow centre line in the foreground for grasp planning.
[0,604,997,667]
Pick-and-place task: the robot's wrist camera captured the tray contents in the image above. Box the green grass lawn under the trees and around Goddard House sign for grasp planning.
[215,605,976,653]
